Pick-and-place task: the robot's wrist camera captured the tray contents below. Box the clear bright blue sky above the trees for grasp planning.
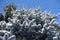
[0,0,60,23]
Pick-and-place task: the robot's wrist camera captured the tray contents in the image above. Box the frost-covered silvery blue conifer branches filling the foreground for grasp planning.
[0,3,60,40]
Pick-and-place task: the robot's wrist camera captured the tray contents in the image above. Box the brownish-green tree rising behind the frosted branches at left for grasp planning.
[4,3,16,22]
